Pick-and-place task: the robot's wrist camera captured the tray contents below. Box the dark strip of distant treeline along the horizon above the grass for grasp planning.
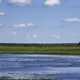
[0,42,80,47]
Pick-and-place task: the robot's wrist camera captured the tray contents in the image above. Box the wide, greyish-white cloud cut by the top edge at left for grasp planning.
[8,0,32,6]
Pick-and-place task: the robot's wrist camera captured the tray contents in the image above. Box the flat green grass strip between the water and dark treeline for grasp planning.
[0,44,80,55]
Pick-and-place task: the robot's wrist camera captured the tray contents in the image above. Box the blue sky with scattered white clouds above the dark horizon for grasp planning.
[0,0,80,43]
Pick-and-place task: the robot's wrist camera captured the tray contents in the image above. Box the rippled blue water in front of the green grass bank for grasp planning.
[0,54,80,80]
